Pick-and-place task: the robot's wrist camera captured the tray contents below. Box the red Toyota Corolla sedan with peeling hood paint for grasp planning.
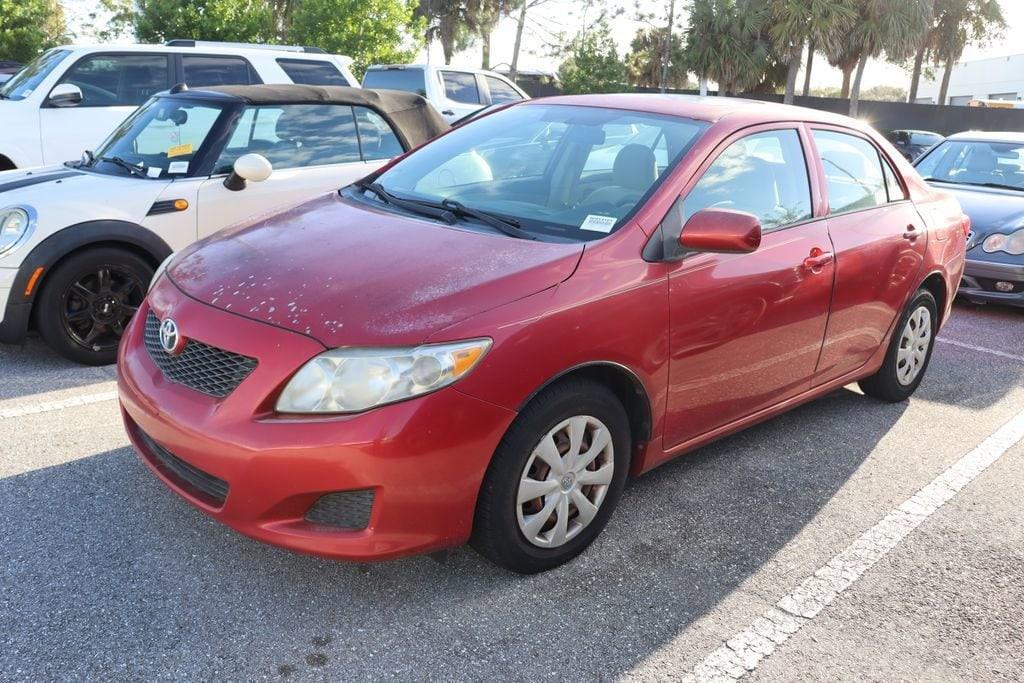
[119,95,968,572]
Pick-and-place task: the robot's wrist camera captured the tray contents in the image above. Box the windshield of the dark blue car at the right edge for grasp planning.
[918,140,1024,189]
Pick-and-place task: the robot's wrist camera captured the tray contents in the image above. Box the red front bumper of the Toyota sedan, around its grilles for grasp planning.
[118,278,515,561]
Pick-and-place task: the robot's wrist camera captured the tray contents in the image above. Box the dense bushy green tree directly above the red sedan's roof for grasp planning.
[684,0,771,95]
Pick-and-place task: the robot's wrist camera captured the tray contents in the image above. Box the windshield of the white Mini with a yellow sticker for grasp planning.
[92,97,224,178]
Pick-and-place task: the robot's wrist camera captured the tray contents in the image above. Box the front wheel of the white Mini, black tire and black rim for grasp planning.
[35,247,154,366]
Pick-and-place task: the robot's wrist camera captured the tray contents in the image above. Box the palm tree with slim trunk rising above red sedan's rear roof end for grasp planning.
[848,0,932,117]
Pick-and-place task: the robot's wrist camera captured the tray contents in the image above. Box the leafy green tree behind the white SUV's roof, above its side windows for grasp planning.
[102,0,278,43]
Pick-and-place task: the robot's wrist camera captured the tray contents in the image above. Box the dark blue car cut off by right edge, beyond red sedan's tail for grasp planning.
[916,132,1024,306]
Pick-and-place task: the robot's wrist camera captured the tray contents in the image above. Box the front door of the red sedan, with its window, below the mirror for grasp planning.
[665,126,834,449]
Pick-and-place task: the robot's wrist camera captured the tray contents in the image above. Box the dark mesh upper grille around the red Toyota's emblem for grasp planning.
[145,311,256,398]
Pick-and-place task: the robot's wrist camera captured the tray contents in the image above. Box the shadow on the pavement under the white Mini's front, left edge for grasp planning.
[0,335,117,401]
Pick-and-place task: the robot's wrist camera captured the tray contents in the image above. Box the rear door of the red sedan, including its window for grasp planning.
[811,126,928,385]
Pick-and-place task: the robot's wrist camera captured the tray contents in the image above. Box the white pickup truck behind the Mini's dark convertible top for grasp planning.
[362,65,529,123]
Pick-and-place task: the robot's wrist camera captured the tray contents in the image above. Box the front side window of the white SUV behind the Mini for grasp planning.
[60,54,170,106]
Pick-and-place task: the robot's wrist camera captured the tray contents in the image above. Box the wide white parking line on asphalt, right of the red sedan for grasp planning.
[644,412,1024,682]
